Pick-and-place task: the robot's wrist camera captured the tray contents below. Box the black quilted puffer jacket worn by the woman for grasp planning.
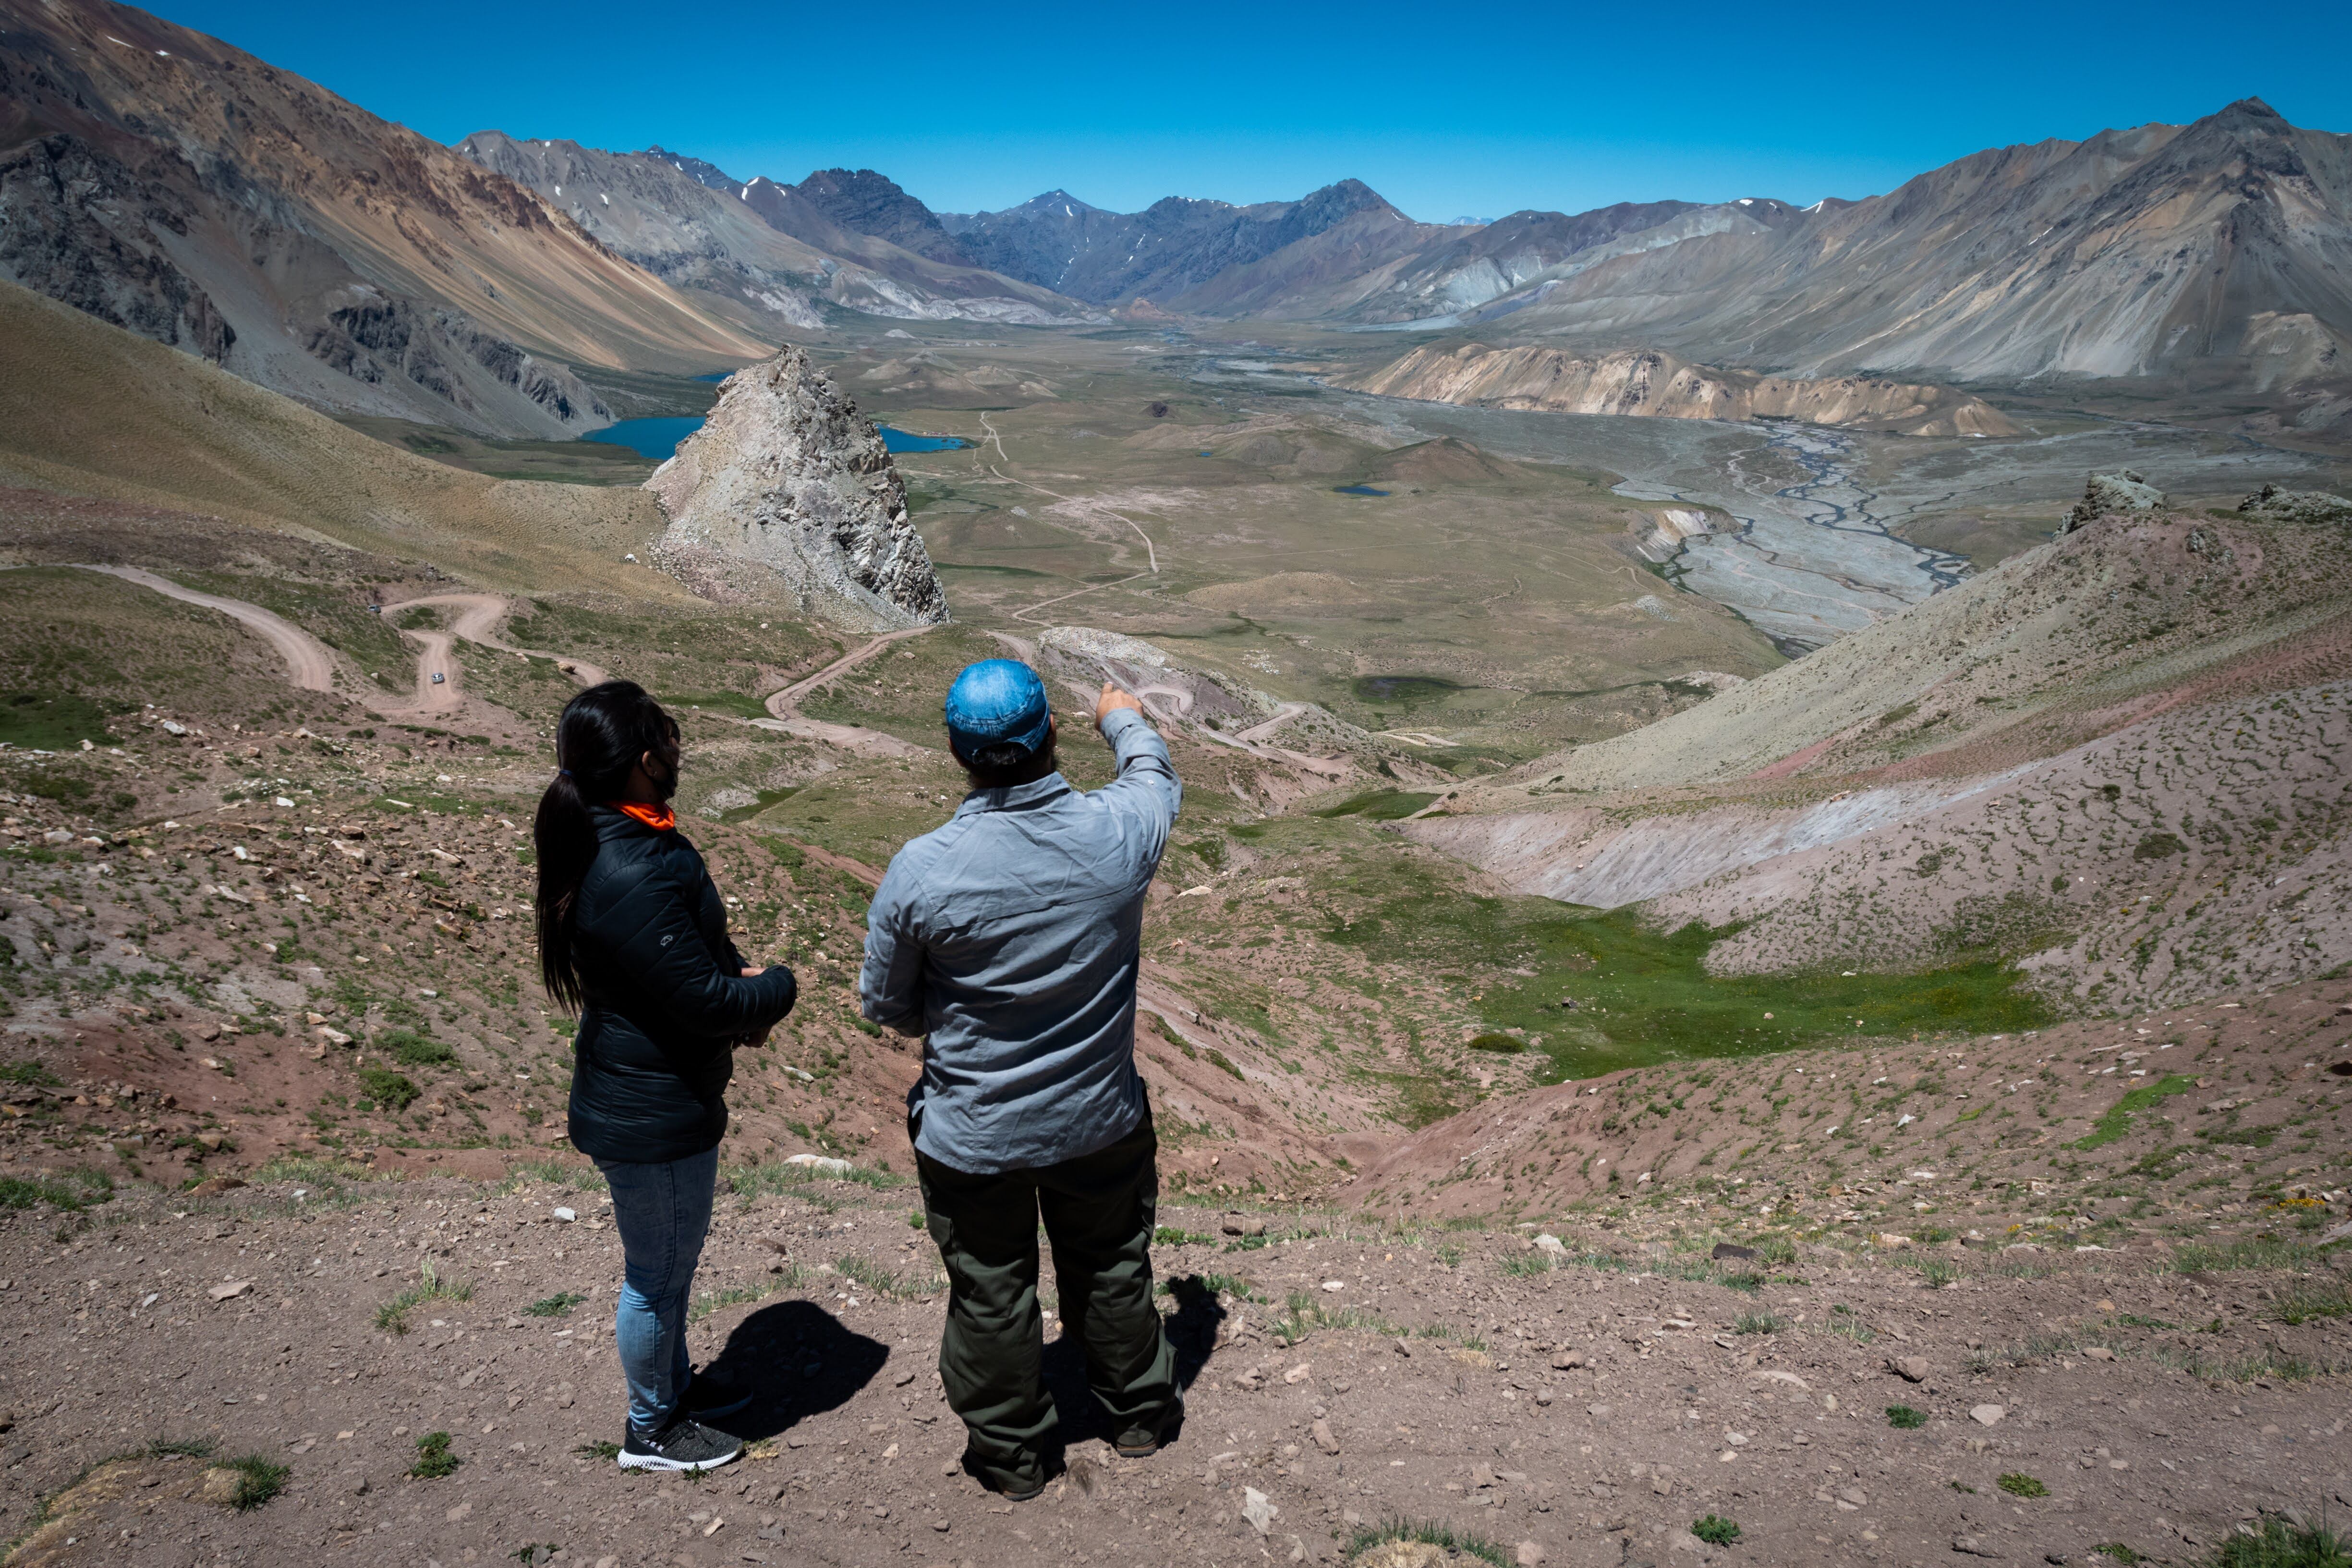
[571,806,797,1161]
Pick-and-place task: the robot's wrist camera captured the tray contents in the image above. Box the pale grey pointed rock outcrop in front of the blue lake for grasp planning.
[644,348,948,628]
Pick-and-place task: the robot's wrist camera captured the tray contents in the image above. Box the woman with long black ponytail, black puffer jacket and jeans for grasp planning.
[532,682,795,1469]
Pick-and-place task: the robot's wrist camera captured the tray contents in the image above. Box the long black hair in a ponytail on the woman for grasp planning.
[532,682,678,1011]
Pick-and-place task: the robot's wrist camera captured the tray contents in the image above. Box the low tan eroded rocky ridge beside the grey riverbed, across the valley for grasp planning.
[1334,343,2018,435]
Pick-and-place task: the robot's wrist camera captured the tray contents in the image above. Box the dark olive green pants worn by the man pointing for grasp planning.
[915,1109,1181,1493]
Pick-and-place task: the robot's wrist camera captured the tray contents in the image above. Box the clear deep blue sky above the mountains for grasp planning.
[160,0,2352,221]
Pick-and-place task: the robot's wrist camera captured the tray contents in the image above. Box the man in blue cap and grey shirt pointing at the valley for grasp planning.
[859,658,1183,1500]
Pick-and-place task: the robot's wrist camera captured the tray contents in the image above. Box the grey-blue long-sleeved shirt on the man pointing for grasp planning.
[859,707,1183,1176]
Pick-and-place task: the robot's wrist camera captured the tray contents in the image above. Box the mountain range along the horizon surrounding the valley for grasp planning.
[0,0,2352,435]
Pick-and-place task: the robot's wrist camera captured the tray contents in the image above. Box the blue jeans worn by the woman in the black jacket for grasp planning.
[595,1150,720,1436]
